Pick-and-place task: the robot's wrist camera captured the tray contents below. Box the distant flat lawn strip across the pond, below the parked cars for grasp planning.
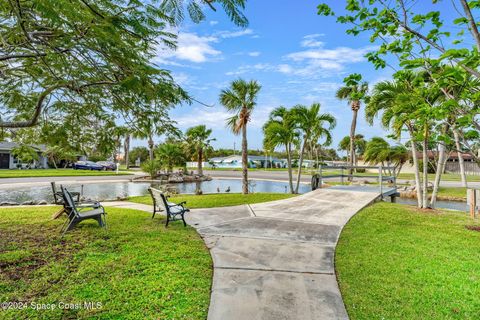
[0,169,131,178]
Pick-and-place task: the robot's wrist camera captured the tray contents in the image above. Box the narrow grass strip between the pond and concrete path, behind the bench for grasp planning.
[128,193,295,209]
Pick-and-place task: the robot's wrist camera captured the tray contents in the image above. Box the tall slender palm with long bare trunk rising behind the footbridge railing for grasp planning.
[336,74,368,174]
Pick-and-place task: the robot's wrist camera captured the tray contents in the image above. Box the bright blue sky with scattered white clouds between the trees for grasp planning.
[138,0,458,149]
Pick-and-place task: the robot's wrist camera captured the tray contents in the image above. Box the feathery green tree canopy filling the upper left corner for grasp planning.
[0,0,189,128]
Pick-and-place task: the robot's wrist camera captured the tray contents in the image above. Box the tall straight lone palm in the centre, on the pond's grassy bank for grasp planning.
[220,79,261,194]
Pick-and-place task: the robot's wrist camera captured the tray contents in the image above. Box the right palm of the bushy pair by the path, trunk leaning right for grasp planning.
[291,103,336,193]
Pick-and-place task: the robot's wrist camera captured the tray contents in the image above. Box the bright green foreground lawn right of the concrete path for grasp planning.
[335,203,480,320]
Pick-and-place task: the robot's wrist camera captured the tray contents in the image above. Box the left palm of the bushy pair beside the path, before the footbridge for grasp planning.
[263,107,300,193]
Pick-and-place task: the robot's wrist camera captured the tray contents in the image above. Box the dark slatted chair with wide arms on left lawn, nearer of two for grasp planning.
[61,186,107,237]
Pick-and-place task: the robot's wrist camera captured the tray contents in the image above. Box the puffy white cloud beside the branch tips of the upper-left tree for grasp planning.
[156,32,222,63]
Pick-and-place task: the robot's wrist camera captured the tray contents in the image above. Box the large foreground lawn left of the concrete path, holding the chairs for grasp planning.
[0,207,212,319]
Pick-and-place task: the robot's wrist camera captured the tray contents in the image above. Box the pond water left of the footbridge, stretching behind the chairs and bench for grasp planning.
[0,179,311,203]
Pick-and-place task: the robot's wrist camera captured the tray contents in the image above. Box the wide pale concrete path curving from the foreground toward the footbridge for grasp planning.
[187,189,378,320]
